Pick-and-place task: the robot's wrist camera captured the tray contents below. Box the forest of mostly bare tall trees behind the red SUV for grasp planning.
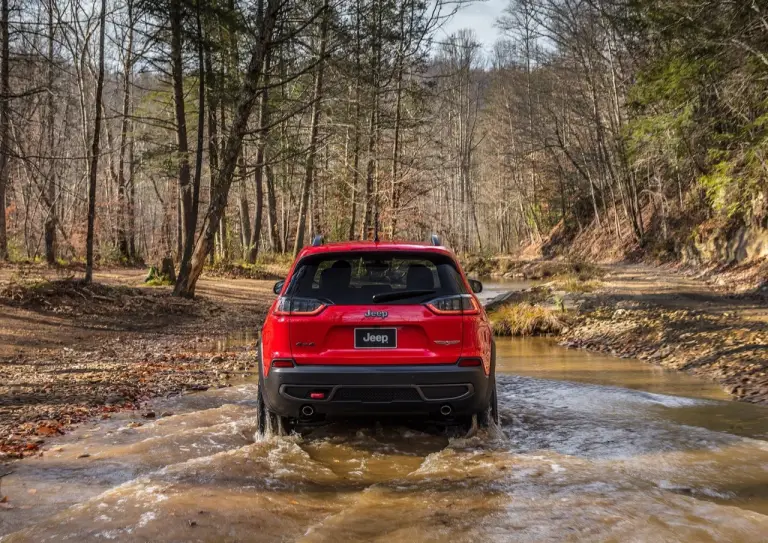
[0,0,768,296]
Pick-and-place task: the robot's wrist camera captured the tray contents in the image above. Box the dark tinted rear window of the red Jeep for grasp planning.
[287,251,467,305]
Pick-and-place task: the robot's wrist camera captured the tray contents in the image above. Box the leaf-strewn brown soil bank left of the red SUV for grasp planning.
[0,267,274,461]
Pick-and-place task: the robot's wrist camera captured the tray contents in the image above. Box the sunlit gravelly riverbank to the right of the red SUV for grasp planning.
[491,265,768,404]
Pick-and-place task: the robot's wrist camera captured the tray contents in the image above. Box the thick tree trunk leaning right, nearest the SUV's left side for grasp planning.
[174,0,282,297]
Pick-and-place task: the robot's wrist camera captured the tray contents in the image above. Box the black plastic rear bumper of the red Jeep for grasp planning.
[262,364,492,418]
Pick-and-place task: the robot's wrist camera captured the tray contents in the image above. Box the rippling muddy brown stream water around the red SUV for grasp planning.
[0,310,768,543]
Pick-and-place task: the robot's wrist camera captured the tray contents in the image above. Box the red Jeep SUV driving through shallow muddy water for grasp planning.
[258,236,498,434]
